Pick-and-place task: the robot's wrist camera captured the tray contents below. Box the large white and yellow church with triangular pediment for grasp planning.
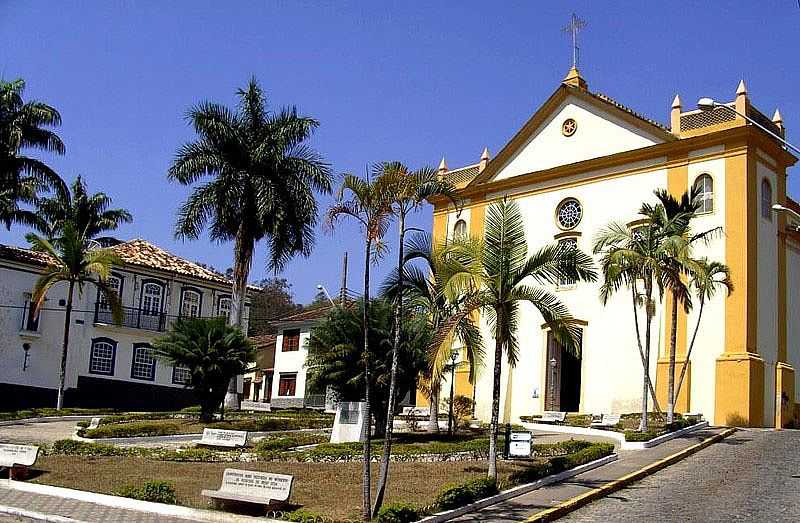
[417,66,800,427]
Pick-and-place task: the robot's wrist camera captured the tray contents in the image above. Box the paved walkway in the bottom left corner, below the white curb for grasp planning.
[0,485,192,523]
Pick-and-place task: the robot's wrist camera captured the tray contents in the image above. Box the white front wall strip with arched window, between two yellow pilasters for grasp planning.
[675,157,726,419]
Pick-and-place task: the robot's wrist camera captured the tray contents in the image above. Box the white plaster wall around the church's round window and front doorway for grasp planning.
[468,164,666,420]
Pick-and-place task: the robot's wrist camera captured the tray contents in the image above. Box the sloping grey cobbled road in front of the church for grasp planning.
[558,429,800,523]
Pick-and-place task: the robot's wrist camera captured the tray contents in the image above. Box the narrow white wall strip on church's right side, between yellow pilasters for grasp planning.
[756,162,778,426]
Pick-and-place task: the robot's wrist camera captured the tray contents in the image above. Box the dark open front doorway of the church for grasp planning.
[544,331,583,412]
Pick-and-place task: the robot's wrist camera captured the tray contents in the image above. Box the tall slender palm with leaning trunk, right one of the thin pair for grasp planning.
[372,162,456,514]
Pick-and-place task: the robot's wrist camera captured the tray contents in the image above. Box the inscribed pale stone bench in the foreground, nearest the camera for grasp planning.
[200,469,294,505]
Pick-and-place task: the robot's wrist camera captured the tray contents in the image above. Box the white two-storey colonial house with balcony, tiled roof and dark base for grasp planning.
[0,239,249,410]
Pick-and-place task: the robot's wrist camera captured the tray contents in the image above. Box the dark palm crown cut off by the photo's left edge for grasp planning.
[0,78,65,229]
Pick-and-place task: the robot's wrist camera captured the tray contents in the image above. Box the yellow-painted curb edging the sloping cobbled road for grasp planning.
[521,428,736,523]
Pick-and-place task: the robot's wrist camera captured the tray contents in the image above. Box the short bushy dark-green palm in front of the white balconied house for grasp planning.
[153,318,255,421]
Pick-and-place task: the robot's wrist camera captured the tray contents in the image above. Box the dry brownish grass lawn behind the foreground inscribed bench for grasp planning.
[31,456,529,520]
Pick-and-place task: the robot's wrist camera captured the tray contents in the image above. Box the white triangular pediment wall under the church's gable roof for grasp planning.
[495,96,663,180]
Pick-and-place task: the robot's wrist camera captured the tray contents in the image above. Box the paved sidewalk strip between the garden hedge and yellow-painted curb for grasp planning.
[446,428,724,523]
